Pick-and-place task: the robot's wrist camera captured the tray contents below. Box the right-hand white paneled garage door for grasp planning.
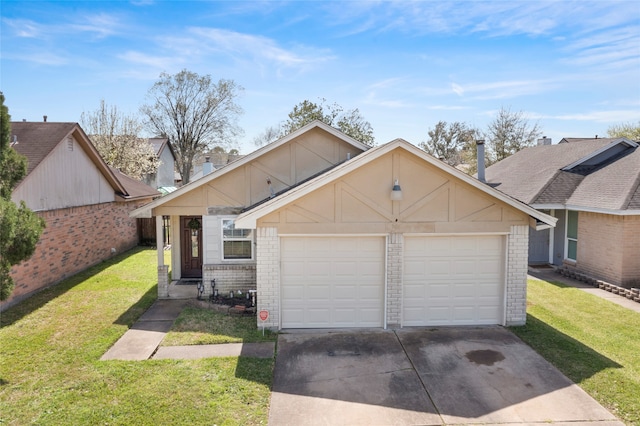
[403,236,504,326]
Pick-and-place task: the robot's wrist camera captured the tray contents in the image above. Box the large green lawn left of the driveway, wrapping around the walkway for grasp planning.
[0,249,273,425]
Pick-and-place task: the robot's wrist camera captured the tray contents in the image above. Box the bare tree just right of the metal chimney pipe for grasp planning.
[487,107,542,163]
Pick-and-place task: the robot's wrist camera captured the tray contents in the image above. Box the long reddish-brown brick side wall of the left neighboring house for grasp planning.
[0,200,150,309]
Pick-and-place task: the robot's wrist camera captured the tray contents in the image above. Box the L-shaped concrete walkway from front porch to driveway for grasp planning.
[100,299,275,361]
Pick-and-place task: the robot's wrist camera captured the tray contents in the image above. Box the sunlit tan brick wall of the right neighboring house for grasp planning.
[575,212,640,287]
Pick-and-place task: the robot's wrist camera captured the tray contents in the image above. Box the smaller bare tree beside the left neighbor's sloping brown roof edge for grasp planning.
[80,99,160,179]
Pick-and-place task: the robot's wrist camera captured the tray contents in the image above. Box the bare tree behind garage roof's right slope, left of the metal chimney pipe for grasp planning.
[420,121,477,166]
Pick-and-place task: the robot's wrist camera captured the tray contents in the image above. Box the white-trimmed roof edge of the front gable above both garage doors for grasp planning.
[236,139,557,229]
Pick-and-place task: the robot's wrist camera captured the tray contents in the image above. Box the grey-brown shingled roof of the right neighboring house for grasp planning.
[486,138,640,214]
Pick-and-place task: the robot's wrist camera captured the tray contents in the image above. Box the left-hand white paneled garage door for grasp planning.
[280,237,385,328]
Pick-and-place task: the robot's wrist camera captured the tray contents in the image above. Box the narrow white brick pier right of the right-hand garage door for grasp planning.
[506,226,529,326]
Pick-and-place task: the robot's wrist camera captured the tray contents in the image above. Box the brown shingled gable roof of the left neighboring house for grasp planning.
[11,121,159,200]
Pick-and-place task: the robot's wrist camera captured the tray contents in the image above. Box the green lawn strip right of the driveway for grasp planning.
[511,279,640,425]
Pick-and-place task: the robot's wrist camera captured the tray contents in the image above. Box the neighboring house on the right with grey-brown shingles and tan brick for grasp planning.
[486,138,640,288]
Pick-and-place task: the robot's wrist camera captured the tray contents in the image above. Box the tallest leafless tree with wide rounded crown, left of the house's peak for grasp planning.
[141,70,242,184]
